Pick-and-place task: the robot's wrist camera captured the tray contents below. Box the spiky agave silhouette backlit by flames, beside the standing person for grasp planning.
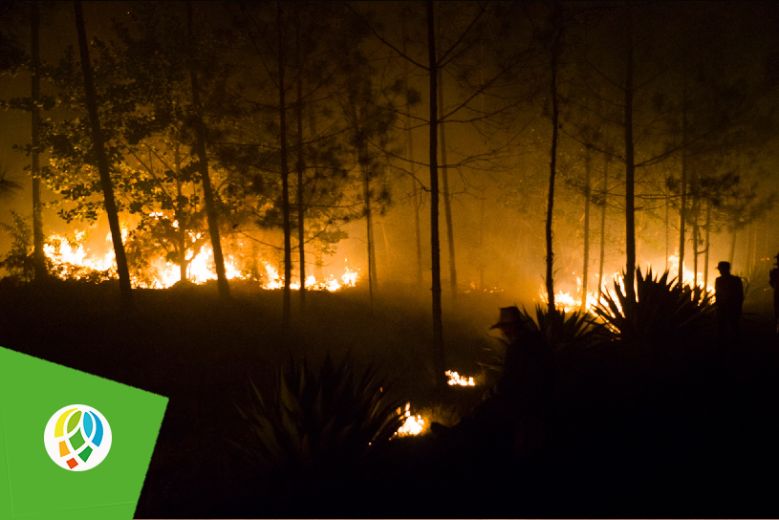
[595,268,713,345]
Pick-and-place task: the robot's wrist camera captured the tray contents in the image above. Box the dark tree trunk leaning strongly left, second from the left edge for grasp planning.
[73,0,133,309]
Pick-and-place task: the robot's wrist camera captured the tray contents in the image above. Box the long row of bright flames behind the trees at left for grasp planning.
[44,230,359,292]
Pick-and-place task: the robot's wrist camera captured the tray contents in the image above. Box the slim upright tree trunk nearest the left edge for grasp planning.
[30,0,47,281]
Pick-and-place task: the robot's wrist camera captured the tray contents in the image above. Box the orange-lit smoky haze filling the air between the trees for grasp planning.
[0,2,779,314]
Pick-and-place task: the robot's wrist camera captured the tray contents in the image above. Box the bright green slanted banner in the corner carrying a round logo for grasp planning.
[0,348,168,520]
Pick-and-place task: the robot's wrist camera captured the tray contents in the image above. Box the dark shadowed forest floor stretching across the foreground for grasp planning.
[0,283,779,518]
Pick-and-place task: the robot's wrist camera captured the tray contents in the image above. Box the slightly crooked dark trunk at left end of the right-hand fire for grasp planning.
[546,2,562,314]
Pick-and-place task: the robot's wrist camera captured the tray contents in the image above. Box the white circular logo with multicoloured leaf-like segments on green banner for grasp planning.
[43,404,112,471]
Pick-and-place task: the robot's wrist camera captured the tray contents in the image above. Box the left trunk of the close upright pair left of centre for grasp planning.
[276,0,292,330]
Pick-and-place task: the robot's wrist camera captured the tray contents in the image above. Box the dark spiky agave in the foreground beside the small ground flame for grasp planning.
[239,355,401,474]
